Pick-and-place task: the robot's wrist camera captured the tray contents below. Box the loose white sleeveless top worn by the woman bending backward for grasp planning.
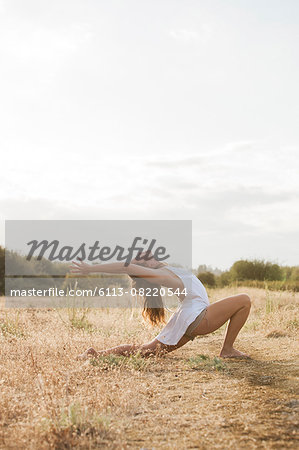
[156,266,210,345]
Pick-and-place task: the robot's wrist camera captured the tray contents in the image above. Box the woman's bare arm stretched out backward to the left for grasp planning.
[71,261,183,289]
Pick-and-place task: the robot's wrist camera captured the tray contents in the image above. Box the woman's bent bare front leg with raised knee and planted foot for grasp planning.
[193,294,251,358]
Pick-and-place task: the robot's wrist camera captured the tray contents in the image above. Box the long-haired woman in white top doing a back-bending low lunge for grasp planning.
[71,257,251,359]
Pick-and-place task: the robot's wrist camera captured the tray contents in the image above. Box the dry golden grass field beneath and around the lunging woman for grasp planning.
[0,288,299,449]
